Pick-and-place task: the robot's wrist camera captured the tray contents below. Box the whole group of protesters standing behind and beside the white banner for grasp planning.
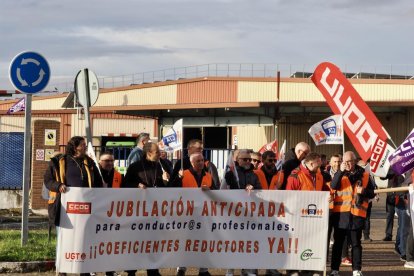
[44,133,414,276]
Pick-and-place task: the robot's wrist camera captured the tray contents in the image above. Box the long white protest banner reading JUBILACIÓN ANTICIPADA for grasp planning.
[56,188,329,273]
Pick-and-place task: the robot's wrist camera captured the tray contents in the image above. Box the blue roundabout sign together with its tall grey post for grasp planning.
[9,52,50,246]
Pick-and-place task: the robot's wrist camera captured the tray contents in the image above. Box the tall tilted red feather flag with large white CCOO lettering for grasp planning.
[312,62,394,176]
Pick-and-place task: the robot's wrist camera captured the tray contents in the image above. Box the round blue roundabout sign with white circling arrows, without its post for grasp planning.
[9,52,50,94]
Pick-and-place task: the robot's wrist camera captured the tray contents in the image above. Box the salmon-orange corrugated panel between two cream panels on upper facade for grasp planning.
[177,80,237,104]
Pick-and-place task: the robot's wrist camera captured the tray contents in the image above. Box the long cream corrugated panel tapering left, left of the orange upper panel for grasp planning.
[95,84,177,106]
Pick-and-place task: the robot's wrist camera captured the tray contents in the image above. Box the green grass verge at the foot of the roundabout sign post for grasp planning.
[0,230,56,262]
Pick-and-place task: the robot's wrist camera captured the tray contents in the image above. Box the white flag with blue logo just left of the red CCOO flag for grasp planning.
[308,115,344,146]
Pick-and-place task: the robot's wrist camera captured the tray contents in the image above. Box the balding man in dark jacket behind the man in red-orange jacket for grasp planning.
[281,142,310,190]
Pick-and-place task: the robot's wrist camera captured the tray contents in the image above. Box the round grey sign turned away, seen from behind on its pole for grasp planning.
[75,69,99,107]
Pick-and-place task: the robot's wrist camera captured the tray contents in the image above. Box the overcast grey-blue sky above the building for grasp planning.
[0,0,414,90]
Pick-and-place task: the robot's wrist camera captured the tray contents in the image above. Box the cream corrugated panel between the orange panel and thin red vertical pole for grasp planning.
[237,81,277,102]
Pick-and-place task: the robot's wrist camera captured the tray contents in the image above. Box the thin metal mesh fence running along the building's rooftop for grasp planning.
[46,63,414,92]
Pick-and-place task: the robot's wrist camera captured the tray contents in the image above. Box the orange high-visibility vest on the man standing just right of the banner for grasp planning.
[333,172,369,218]
